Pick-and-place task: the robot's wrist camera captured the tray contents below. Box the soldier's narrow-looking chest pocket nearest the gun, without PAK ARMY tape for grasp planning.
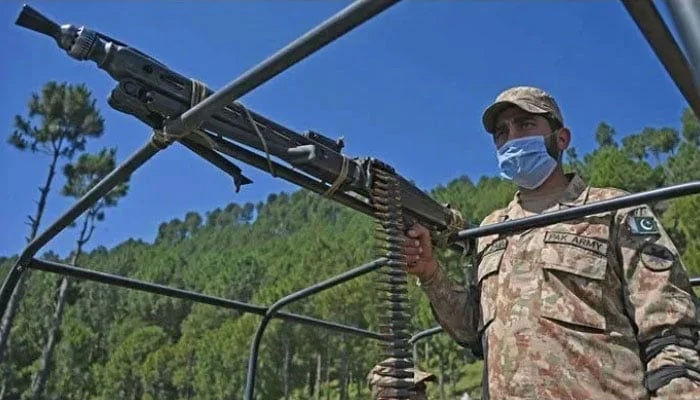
[477,240,506,333]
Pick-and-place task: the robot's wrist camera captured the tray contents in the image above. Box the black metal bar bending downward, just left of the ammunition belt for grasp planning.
[245,257,387,400]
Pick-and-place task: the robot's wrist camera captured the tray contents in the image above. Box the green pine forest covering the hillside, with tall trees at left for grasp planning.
[0,82,700,400]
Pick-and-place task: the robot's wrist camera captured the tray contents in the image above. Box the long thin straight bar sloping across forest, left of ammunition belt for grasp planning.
[28,258,382,340]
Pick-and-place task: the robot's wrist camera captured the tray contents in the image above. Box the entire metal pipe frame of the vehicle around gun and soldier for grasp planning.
[0,0,700,399]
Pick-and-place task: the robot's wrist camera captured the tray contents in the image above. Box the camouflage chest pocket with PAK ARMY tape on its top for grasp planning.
[540,232,608,330]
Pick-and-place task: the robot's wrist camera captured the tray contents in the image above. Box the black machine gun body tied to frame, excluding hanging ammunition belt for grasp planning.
[16,5,464,250]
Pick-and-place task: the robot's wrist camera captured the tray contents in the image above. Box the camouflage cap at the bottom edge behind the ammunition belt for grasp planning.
[367,358,437,400]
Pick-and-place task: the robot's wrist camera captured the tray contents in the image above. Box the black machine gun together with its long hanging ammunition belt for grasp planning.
[12,4,464,399]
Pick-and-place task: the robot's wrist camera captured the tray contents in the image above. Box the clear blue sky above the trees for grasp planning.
[0,0,686,255]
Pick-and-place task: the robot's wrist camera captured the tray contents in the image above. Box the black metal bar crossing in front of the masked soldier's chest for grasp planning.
[451,181,700,240]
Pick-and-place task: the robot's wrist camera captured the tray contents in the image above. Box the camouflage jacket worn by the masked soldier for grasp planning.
[421,175,700,400]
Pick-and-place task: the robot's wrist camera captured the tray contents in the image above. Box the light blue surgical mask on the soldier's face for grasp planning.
[498,136,557,189]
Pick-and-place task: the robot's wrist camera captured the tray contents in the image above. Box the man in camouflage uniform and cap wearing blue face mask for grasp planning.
[405,87,700,400]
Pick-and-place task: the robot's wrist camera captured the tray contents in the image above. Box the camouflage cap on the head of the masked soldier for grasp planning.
[482,86,564,133]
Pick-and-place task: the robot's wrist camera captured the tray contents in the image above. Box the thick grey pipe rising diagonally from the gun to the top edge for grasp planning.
[165,0,398,135]
